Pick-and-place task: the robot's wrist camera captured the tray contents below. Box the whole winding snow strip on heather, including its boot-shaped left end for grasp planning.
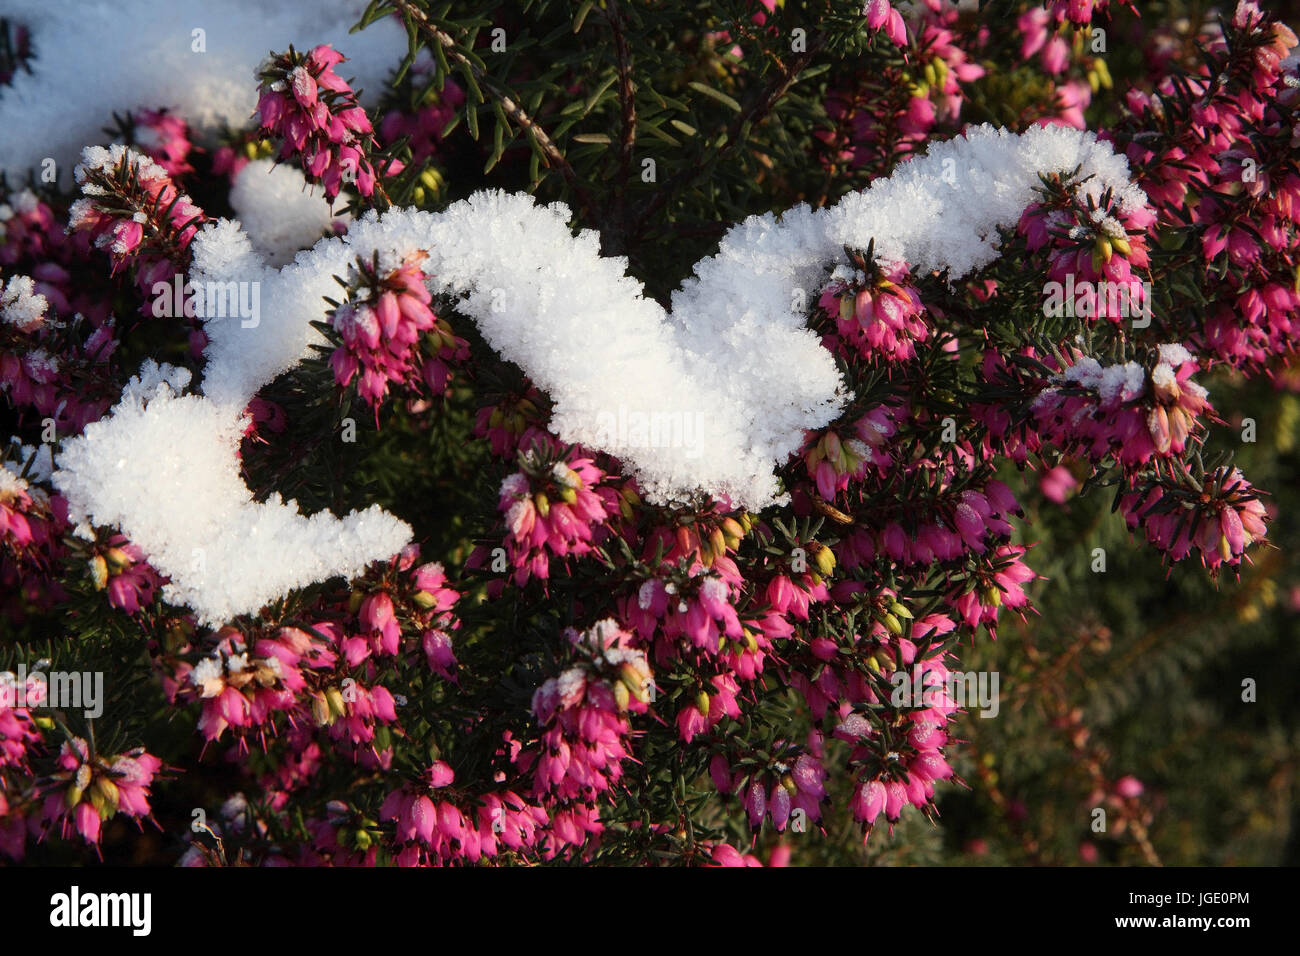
[45,119,1145,623]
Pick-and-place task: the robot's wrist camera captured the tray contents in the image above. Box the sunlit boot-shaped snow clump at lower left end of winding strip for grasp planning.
[53,363,411,627]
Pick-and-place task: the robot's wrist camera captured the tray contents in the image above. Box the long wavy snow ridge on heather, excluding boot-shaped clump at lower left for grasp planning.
[192,126,1145,510]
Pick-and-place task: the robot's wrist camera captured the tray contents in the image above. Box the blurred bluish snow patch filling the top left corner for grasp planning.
[0,0,407,183]
